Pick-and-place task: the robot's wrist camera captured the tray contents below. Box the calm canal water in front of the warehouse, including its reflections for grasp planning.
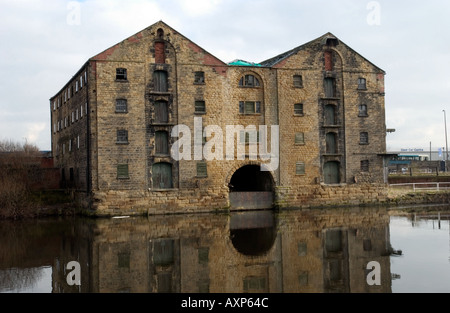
[0,206,450,293]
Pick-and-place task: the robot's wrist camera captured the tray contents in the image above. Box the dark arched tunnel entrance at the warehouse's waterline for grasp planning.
[229,165,274,209]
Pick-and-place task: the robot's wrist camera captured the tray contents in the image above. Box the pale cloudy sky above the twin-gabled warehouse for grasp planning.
[0,0,450,152]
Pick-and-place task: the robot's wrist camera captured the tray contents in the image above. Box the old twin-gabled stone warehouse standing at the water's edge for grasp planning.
[50,21,387,215]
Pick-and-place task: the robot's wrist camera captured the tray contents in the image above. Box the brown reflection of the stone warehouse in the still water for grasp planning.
[46,209,391,293]
